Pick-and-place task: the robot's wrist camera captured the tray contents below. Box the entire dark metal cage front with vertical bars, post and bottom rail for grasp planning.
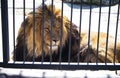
[0,0,120,70]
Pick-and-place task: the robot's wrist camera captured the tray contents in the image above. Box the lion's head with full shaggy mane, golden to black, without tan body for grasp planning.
[13,5,79,62]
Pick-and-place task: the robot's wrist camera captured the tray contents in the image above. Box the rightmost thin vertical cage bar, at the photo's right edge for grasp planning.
[113,0,120,65]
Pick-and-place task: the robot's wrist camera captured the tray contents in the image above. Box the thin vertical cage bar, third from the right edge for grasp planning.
[96,0,102,65]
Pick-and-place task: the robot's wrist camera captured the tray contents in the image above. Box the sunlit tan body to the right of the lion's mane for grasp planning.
[80,32,120,63]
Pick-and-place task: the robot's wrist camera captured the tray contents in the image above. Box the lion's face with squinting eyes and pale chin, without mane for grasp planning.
[44,18,67,52]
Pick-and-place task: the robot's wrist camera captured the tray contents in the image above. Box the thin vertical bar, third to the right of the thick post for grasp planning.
[33,0,36,64]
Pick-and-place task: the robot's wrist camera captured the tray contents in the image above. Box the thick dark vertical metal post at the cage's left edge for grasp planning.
[1,0,9,65]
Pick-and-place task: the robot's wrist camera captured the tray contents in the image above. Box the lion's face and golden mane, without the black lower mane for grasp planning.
[19,6,70,57]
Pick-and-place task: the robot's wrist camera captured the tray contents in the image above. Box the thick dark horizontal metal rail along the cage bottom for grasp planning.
[0,63,120,70]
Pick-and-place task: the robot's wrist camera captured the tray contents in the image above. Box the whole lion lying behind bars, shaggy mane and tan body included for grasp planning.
[13,5,120,63]
